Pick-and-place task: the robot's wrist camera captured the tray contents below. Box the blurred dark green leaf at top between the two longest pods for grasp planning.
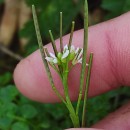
[39,0,81,38]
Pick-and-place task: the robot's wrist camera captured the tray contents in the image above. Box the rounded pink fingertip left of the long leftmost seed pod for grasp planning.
[14,51,60,103]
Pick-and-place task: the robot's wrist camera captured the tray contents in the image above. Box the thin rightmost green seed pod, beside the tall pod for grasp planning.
[82,53,93,127]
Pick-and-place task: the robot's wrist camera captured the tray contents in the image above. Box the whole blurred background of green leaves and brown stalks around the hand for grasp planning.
[0,0,130,130]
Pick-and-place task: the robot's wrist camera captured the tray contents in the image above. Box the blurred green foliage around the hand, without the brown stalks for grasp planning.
[0,0,130,130]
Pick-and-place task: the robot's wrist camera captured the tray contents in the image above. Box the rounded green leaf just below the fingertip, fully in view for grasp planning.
[20,104,38,119]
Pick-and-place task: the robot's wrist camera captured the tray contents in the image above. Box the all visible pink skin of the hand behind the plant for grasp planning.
[14,13,130,130]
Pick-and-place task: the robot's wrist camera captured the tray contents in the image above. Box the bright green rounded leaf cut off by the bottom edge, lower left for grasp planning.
[11,122,29,130]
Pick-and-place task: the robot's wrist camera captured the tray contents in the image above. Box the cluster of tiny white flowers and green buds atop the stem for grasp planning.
[45,45,83,65]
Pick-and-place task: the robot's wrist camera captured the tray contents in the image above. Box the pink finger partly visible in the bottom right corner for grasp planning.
[68,103,130,130]
